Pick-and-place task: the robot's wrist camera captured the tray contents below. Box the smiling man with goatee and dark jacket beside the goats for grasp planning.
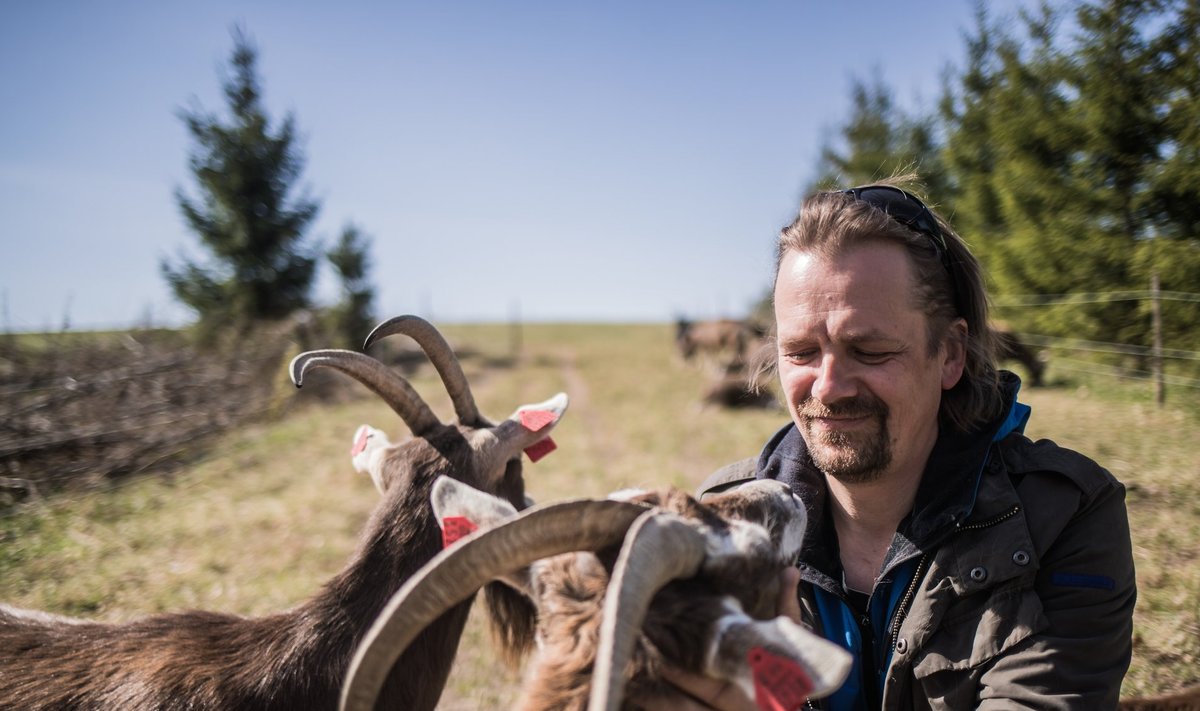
[657,180,1135,711]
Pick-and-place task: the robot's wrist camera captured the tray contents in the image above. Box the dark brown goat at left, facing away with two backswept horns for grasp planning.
[0,316,568,711]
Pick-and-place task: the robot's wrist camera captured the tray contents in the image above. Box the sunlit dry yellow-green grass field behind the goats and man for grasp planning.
[0,324,1200,710]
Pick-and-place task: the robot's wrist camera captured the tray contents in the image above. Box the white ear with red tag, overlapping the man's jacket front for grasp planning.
[706,609,852,709]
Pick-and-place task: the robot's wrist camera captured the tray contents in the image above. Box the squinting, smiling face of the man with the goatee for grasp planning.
[775,241,965,484]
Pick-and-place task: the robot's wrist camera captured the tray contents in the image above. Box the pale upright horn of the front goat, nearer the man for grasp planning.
[588,510,704,711]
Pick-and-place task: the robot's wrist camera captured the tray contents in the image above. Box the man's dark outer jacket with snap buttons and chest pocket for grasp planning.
[700,378,1135,711]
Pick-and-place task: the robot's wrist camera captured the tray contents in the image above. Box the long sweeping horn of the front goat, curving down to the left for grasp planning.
[341,500,647,711]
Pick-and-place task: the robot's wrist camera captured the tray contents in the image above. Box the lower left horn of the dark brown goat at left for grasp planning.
[288,348,442,436]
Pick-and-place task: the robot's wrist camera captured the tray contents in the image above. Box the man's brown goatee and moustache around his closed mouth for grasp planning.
[796,395,892,484]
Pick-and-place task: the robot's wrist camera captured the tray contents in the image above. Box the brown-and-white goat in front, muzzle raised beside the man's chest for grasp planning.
[342,479,850,711]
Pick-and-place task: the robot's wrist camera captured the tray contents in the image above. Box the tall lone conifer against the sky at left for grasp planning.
[162,29,319,333]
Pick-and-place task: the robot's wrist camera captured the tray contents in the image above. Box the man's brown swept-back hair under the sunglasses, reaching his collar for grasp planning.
[772,175,1006,431]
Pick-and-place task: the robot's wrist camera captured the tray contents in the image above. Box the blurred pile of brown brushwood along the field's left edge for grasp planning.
[0,331,296,508]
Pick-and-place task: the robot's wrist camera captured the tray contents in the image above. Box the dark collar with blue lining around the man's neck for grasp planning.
[757,371,1030,583]
